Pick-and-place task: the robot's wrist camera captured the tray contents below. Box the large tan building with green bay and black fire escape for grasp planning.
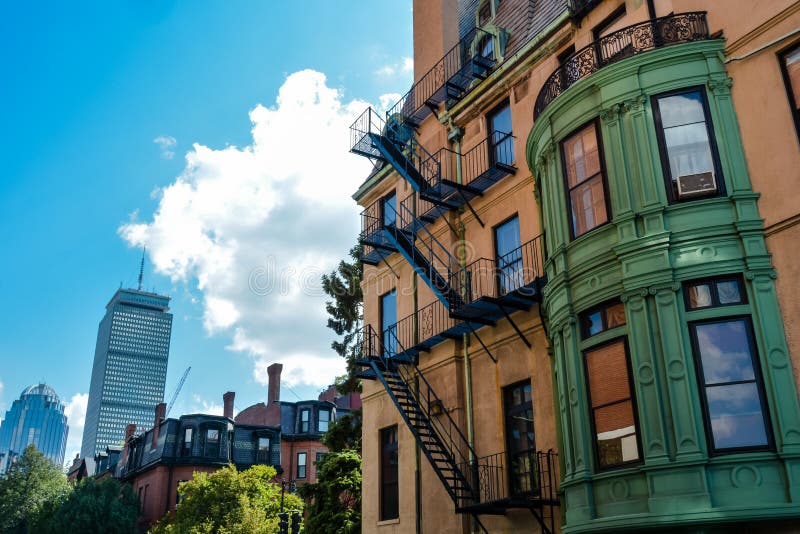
[350,0,800,533]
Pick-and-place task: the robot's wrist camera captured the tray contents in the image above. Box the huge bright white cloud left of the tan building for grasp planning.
[119,70,370,386]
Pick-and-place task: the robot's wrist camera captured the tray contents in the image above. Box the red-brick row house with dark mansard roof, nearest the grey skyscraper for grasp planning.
[115,392,282,525]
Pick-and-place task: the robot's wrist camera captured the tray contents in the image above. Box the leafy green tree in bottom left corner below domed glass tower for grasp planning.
[0,445,69,533]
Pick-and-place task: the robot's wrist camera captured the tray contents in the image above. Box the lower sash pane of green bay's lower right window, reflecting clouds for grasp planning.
[706,382,769,449]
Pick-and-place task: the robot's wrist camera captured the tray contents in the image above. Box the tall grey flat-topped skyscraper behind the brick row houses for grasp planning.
[81,289,172,458]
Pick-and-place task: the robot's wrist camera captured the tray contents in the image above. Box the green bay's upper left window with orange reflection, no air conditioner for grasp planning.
[561,122,608,238]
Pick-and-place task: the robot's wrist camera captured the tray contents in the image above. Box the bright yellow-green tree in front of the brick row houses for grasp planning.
[150,465,303,534]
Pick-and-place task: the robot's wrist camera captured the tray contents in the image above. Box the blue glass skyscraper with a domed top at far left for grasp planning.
[0,384,69,474]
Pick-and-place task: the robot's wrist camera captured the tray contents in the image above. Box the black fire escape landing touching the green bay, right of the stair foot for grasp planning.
[450,236,545,322]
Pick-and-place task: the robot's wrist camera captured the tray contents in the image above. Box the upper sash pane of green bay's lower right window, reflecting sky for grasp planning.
[695,319,755,384]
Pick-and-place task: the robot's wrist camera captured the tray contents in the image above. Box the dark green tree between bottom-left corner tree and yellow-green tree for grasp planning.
[31,478,139,534]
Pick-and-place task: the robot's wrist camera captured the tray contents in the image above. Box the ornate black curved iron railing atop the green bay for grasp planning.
[533,11,709,118]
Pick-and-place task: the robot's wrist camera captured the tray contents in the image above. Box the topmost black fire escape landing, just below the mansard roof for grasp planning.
[386,28,496,128]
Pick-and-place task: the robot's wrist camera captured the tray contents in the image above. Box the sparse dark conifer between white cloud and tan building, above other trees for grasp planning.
[322,245,364,393]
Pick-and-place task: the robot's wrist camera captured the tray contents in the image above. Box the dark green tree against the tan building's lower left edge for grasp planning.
[298,450,361,534]
